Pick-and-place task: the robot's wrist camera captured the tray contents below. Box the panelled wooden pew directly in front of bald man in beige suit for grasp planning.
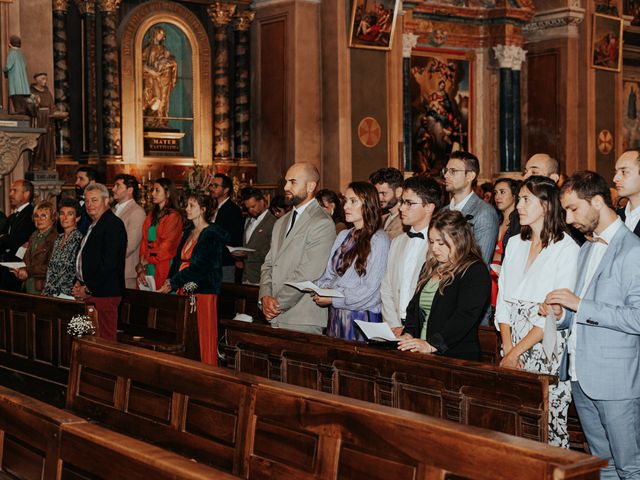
[223,320,555,442]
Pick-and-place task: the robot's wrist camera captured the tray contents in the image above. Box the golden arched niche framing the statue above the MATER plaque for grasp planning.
[119,0,212,165]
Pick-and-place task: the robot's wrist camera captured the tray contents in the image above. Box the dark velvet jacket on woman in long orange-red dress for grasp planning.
[169,225,229,293]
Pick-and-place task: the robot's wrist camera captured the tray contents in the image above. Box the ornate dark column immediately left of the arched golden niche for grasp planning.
[98,0,122,156]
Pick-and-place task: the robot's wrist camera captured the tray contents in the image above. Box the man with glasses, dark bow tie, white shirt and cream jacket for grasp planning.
[380,177,442,335]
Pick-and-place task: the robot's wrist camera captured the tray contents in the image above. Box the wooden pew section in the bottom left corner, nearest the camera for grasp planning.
[0,387,237,480]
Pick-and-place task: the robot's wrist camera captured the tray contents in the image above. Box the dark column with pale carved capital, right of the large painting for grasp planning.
[493,45,527,172]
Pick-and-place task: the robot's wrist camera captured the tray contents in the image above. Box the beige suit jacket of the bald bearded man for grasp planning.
[259,200,336,333]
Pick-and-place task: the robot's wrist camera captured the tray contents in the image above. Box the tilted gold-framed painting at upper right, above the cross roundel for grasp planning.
[591,13,623,72]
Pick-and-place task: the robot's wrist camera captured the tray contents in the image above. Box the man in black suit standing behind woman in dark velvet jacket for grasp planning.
[210,173,244,282]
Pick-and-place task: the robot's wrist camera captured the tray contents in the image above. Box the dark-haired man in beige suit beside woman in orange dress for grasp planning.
[112,173,148,288]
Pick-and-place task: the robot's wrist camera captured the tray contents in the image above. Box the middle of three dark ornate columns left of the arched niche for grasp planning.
[75,0,98,154]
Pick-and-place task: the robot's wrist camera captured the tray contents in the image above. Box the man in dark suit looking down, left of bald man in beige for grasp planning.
[232,187,276,285]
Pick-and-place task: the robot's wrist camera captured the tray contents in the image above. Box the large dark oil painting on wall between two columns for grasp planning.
[409,50,473,174]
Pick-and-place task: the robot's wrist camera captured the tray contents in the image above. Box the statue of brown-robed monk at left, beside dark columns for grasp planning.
[29,72,69,171]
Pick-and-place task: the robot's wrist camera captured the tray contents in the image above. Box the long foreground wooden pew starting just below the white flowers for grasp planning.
[63,338,605,480]
